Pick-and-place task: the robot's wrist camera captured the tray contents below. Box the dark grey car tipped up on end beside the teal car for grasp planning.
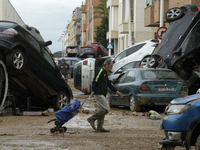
[141,5,200,94]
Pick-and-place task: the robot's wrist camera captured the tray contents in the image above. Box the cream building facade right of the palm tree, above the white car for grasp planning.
[107,0,155,55]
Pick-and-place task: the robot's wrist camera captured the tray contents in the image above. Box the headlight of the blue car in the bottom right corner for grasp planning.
[165,104,190,115]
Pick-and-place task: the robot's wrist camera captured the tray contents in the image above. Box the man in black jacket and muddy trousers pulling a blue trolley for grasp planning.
[87,59,123,132]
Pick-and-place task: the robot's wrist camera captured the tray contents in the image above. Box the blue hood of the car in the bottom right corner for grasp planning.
[170,94,200,105]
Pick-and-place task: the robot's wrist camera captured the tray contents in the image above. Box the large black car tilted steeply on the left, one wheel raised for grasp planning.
[0,21,73,109]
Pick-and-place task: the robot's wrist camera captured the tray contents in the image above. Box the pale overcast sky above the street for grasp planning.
[9,0,85,53]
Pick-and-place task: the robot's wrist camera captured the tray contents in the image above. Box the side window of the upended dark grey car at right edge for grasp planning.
[181,21,200,55]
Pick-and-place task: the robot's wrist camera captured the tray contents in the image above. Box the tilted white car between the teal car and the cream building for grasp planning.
[111,39,159,74]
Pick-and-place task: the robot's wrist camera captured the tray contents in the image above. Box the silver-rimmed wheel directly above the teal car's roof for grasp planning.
[140,56,158,68]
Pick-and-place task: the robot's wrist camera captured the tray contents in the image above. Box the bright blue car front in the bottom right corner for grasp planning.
[159,94,200,150]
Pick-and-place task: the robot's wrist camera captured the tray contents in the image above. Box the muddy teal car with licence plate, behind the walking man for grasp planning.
[107,68,188,111]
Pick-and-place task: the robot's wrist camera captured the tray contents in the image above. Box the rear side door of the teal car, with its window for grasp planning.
[118,70,135,106]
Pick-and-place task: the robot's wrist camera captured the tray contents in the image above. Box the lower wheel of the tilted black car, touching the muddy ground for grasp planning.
[54,92,70,110]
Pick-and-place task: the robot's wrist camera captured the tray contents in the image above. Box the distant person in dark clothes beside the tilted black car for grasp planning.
[59,58,71,82]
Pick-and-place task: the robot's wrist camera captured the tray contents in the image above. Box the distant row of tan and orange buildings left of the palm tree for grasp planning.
[64,0,101,52]
